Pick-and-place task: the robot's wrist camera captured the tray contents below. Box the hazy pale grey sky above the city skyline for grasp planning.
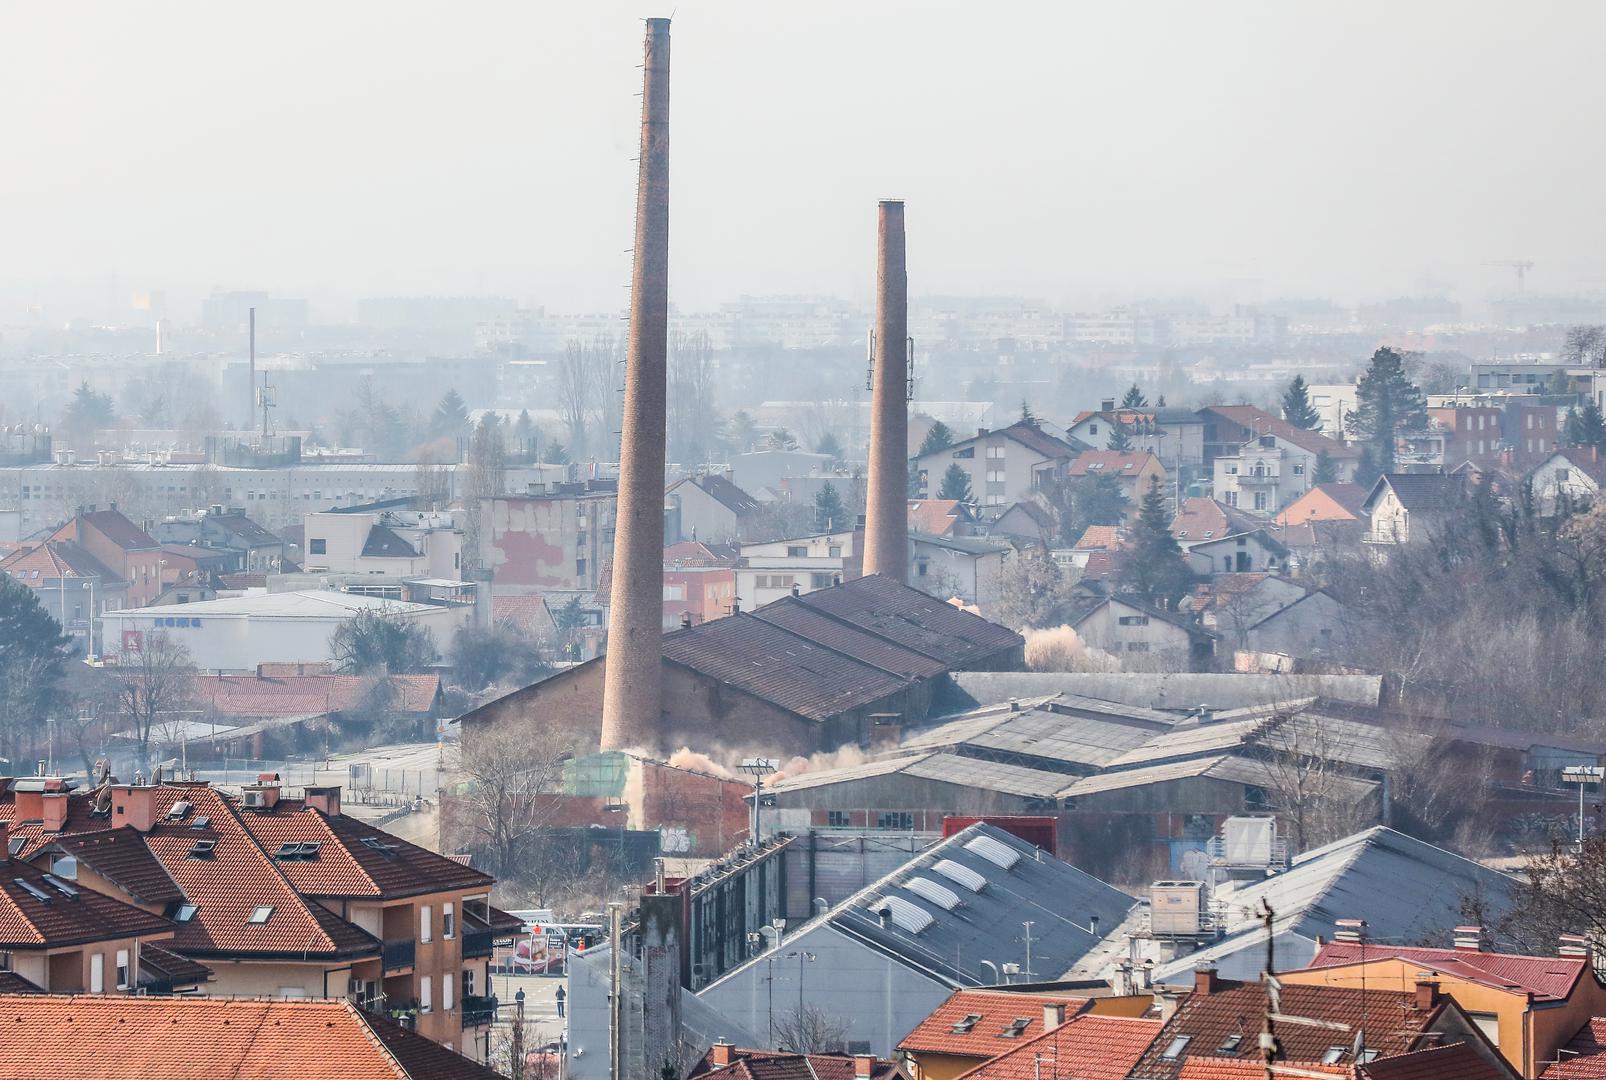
[0,0,1606,310]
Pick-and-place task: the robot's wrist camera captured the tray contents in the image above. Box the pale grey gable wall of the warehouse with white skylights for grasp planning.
[697,924,951,1058]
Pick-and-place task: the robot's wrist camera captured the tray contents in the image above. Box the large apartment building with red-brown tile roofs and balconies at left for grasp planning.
[0,773,519,1059]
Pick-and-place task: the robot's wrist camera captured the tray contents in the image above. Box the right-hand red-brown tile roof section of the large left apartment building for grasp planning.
[239,799,495,900]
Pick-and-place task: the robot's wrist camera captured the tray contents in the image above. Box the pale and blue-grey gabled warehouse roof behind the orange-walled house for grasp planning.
[1155,824,1514,984]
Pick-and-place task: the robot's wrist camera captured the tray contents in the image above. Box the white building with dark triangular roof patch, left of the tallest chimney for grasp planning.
[302,500,463,580]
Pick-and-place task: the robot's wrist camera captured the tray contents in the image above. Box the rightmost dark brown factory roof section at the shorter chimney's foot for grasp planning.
[800,574,1025,669]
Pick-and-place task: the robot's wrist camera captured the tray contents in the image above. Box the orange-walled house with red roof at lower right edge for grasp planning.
[1277,926,1606,1077]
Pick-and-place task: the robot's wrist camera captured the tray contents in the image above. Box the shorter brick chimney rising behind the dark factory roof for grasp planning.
[864,203,909,582]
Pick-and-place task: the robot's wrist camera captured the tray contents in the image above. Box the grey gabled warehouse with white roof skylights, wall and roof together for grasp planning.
[699,824,1135,1056]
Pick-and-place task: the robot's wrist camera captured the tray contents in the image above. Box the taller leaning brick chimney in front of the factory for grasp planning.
[602,19,670,751]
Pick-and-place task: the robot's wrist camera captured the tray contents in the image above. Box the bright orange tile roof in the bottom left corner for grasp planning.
[0,993,499,1080]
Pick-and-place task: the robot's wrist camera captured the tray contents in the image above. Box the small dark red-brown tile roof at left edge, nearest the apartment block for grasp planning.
[0,858,177,950]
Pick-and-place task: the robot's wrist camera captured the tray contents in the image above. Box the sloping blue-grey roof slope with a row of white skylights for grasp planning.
[748,823,1135,988]
